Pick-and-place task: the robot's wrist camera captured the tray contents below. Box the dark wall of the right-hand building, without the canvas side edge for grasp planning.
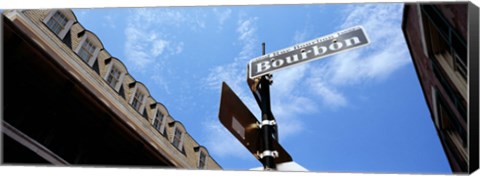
[402,3,468,172]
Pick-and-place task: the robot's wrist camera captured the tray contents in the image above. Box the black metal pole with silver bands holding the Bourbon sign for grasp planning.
[259,43,277,170]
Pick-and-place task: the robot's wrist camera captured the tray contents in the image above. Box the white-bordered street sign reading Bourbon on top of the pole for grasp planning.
[248,26,369,79]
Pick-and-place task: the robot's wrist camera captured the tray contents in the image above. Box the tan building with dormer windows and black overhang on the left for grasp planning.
[2,9,221,169]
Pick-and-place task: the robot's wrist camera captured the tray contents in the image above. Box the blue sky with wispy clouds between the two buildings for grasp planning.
[74,3,451,173]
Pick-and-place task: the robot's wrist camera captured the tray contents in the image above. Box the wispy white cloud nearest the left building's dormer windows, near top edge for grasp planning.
[125,8,207,72]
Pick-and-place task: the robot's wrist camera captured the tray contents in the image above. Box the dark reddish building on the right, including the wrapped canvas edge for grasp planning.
[402,2,478,173]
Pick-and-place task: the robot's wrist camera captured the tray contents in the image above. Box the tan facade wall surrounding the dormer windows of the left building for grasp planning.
[3,9,221,169]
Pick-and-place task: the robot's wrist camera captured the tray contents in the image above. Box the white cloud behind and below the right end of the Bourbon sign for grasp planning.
[296,4,410,108]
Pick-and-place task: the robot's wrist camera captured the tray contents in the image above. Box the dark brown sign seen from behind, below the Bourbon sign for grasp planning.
[218,82,292,163]
